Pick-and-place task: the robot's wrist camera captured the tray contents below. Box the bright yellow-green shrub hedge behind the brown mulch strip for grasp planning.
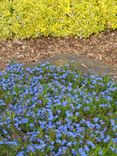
[0,0,117,39]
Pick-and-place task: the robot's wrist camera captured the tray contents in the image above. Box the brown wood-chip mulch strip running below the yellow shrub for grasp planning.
[0,30,117,81]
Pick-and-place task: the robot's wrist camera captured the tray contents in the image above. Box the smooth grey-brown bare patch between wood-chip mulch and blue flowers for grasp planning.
[40,54,117,81]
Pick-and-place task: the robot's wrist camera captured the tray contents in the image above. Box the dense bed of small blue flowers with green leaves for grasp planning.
[0,62,117,156]
